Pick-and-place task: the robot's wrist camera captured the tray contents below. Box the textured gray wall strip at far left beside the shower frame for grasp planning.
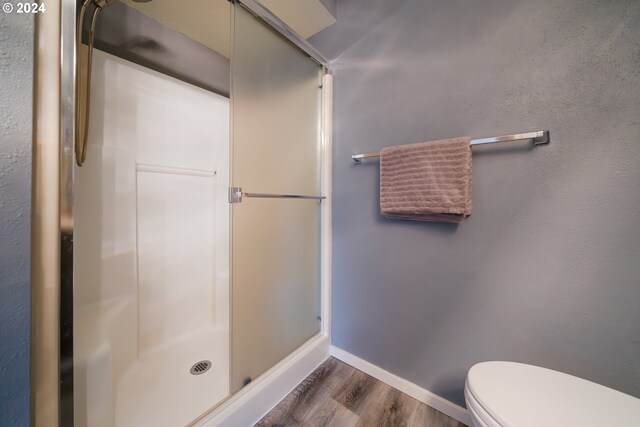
[0,13,33,426]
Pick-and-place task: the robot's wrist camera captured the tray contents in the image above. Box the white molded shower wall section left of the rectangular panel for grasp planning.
[74,145,136,307]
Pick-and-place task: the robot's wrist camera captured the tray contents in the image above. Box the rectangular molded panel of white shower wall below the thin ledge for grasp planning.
[138,171,215,355]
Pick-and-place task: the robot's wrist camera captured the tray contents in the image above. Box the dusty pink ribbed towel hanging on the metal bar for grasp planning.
[380,137,472,223]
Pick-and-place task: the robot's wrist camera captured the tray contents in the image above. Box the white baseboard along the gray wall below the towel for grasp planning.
[331,346,471,426]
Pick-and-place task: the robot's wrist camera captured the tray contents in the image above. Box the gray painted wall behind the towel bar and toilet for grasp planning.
[313,0,640,404]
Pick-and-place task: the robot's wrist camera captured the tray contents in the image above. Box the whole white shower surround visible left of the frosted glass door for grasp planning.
[74,50,229,426]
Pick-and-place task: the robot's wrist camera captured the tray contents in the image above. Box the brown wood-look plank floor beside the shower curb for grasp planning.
[256,357,465,427]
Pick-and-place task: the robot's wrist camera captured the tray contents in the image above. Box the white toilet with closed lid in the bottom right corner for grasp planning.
[464,362,640,427]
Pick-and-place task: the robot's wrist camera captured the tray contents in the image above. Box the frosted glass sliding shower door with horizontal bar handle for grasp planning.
[229,3,323,392]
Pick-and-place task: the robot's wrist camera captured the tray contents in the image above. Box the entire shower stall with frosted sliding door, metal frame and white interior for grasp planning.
[32,0,331,426]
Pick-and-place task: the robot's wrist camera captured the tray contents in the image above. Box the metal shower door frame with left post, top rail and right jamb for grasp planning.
[30,0,332,427]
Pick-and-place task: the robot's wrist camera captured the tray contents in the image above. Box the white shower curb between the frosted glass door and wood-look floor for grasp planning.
[194,335,329,427]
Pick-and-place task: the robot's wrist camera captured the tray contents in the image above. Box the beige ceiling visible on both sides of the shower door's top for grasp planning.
[122,0,336,58]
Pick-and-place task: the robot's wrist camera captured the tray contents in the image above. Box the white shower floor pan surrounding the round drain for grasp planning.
[115,327,229,427]
